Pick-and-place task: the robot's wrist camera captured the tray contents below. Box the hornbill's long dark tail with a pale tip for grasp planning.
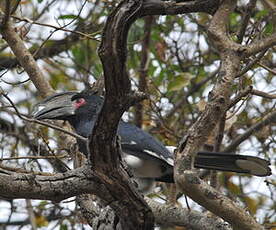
[194,152,271,176]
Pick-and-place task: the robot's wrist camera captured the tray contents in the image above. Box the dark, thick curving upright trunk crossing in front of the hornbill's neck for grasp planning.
[89,0,154,229]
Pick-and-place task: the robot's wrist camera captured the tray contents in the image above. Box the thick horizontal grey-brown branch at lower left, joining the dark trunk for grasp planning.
[0,167,113,202]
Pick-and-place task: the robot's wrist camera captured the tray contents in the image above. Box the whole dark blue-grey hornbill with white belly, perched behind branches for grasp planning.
[33,91,271,190]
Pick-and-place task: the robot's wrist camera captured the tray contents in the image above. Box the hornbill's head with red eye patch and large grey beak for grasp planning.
[33,91,103,121]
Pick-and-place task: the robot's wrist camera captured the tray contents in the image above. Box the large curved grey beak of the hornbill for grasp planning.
[32,91,77,120]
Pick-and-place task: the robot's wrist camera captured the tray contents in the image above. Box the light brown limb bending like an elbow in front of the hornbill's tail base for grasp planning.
[174,0,262,230]
